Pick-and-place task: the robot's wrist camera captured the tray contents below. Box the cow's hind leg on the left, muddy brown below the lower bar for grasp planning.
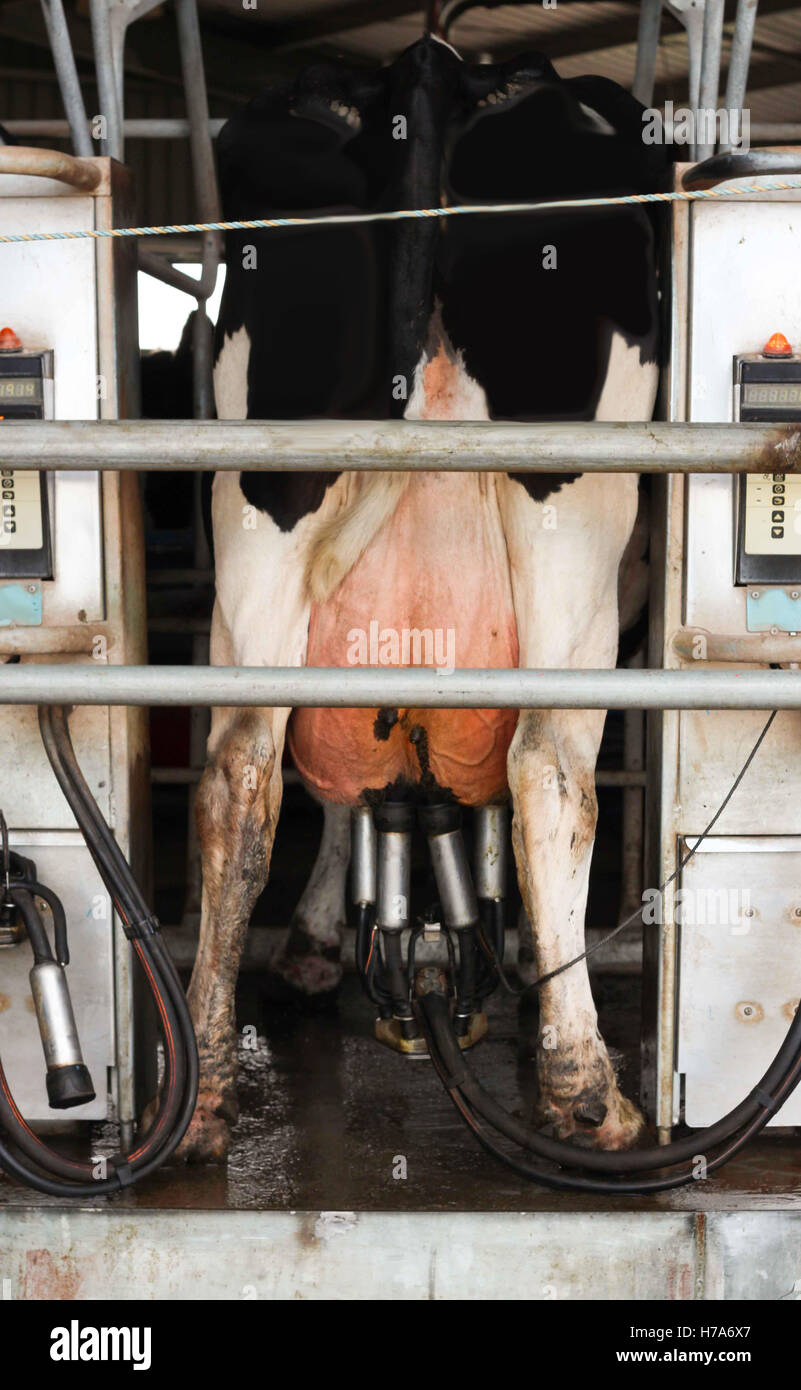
[182,474,330,1159]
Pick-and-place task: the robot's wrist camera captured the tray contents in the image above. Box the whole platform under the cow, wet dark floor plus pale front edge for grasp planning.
[0,976,801,1302]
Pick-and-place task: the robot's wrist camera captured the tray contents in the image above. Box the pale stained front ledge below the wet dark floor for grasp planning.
[0,1207,801,1301]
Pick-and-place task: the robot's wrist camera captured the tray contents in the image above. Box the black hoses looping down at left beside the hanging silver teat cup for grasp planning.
[0,706,197,1197]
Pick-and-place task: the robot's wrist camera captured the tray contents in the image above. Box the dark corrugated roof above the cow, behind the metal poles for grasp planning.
[0,0,801,230]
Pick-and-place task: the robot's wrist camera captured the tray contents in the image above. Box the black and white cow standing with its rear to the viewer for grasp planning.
[184,38,662,1159]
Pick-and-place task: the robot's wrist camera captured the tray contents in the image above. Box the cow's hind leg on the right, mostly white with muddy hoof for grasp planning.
[499,475,642,1148]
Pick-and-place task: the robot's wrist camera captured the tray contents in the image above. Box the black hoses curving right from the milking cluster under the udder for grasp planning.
[417,991,801,1194]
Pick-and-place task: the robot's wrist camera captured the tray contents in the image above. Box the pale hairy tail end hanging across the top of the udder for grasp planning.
[306,473,412,603]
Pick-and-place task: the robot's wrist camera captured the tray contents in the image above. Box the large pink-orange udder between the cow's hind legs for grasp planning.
[289,474,517,805]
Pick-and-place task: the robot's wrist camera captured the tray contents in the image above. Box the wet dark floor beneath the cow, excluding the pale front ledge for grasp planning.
[0,974,801,1212]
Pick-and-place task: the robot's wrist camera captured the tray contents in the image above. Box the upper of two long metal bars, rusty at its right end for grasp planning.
[0,420,801,473]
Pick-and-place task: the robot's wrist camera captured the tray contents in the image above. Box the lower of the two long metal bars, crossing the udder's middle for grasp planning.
[0,663,801,709]
